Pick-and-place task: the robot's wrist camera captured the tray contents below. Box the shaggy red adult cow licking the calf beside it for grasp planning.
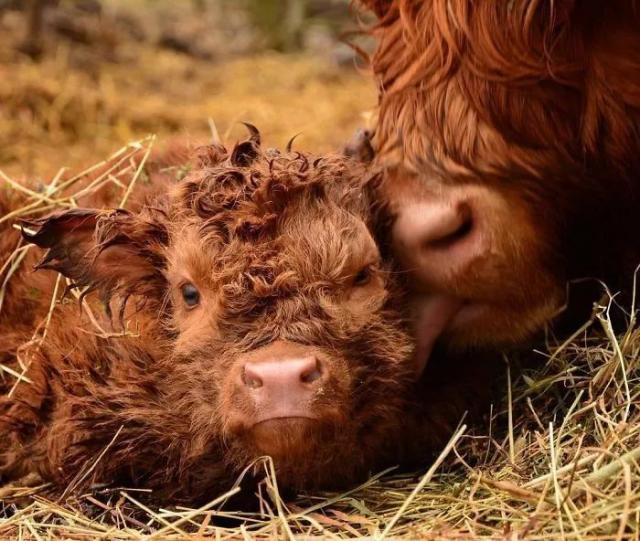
[363,0,640,368]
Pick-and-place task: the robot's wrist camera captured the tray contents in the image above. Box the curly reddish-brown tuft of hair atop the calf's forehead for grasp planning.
[179,127,371,240]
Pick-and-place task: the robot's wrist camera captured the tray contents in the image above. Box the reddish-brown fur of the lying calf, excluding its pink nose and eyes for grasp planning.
[0,137,490,500]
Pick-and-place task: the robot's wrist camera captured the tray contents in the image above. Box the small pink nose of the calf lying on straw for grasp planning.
[243,355,322,393]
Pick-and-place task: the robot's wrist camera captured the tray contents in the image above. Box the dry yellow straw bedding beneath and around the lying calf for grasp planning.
[0,138,640,540]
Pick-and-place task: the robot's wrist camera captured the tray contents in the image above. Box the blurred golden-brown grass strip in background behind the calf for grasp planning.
[0,28,376,179]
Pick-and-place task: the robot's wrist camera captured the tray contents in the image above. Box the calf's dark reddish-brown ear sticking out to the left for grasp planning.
[22,208,168,312]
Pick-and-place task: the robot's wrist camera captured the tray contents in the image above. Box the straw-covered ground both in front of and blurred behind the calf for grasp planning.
[0,2,640,540]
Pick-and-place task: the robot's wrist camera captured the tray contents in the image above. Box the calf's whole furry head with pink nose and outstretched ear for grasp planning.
[26,135,415,494]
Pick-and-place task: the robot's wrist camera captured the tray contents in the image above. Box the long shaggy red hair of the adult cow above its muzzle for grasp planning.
[372,0,640,173]
